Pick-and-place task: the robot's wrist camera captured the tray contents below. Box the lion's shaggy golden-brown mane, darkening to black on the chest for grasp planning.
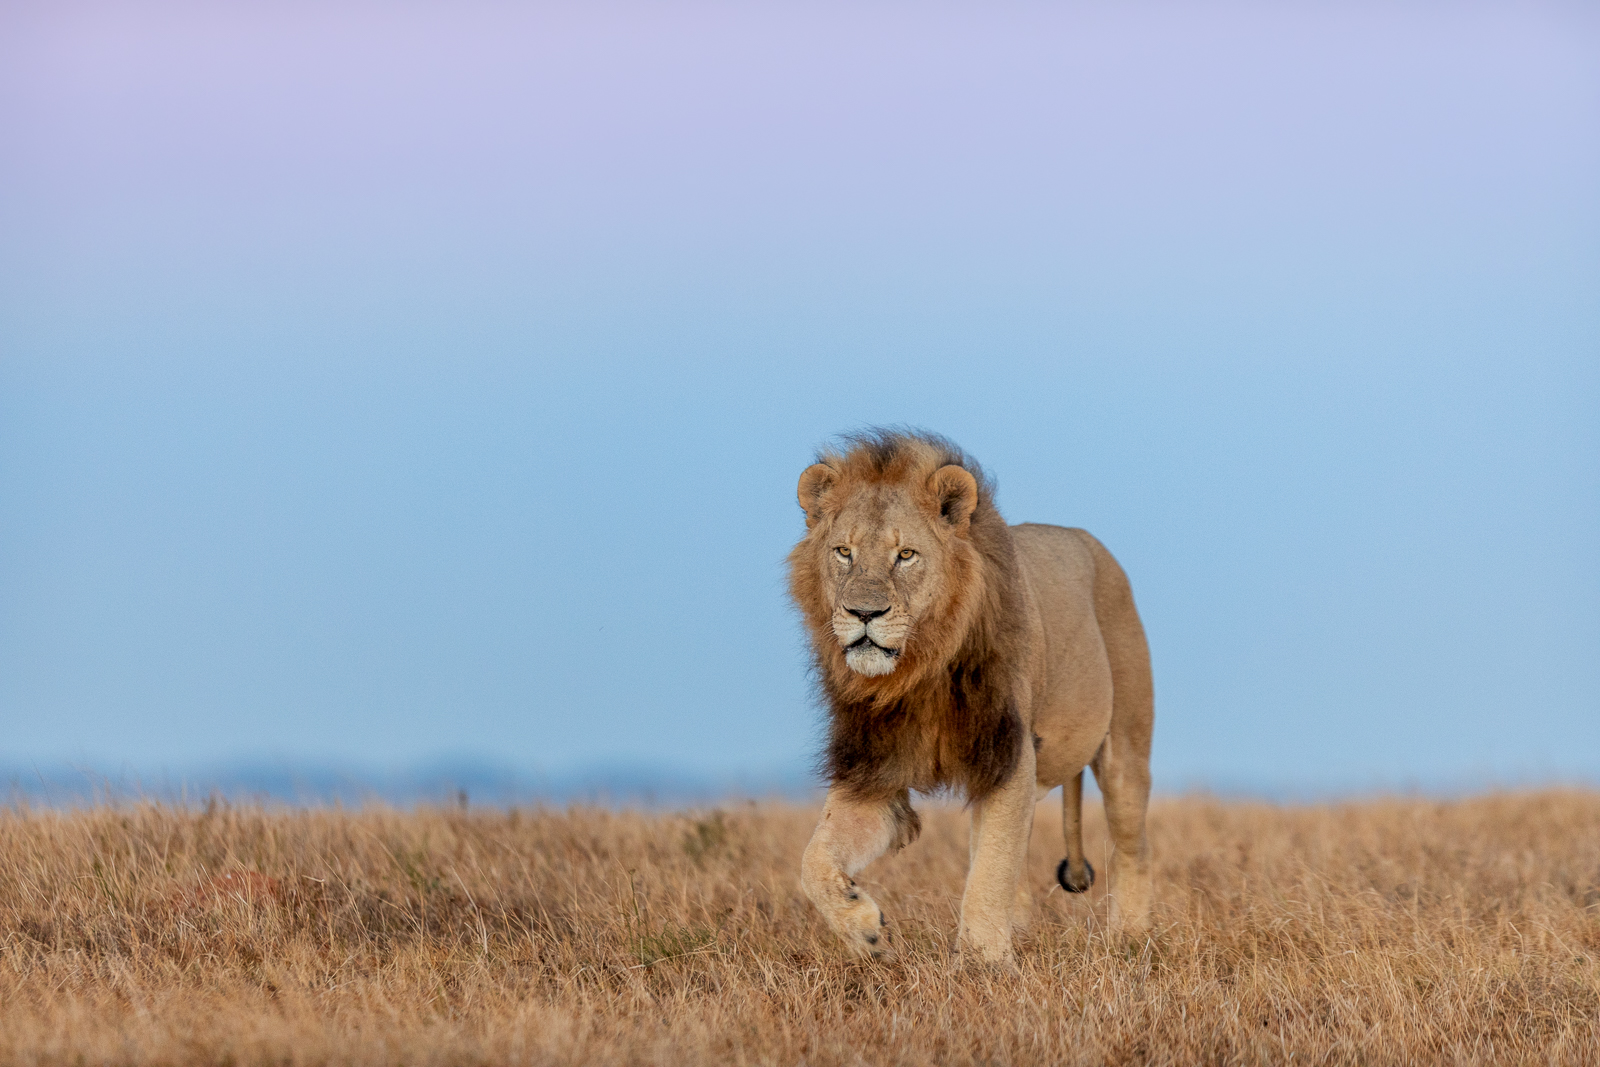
[789,430,1027,800]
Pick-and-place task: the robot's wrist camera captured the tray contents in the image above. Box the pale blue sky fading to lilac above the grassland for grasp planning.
[0,0,1600,790]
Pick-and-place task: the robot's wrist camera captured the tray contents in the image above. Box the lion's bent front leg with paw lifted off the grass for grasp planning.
[800,787,922,958]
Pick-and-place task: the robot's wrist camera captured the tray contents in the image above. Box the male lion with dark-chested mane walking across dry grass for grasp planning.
[789,430,1155,966]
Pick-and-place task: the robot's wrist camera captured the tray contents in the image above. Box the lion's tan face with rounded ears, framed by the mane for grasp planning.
[797,464,976,678]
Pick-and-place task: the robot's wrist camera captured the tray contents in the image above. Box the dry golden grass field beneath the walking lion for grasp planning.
[0,790,1600,1065]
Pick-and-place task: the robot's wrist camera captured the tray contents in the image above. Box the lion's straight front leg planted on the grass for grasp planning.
[957,745,1034,965]
